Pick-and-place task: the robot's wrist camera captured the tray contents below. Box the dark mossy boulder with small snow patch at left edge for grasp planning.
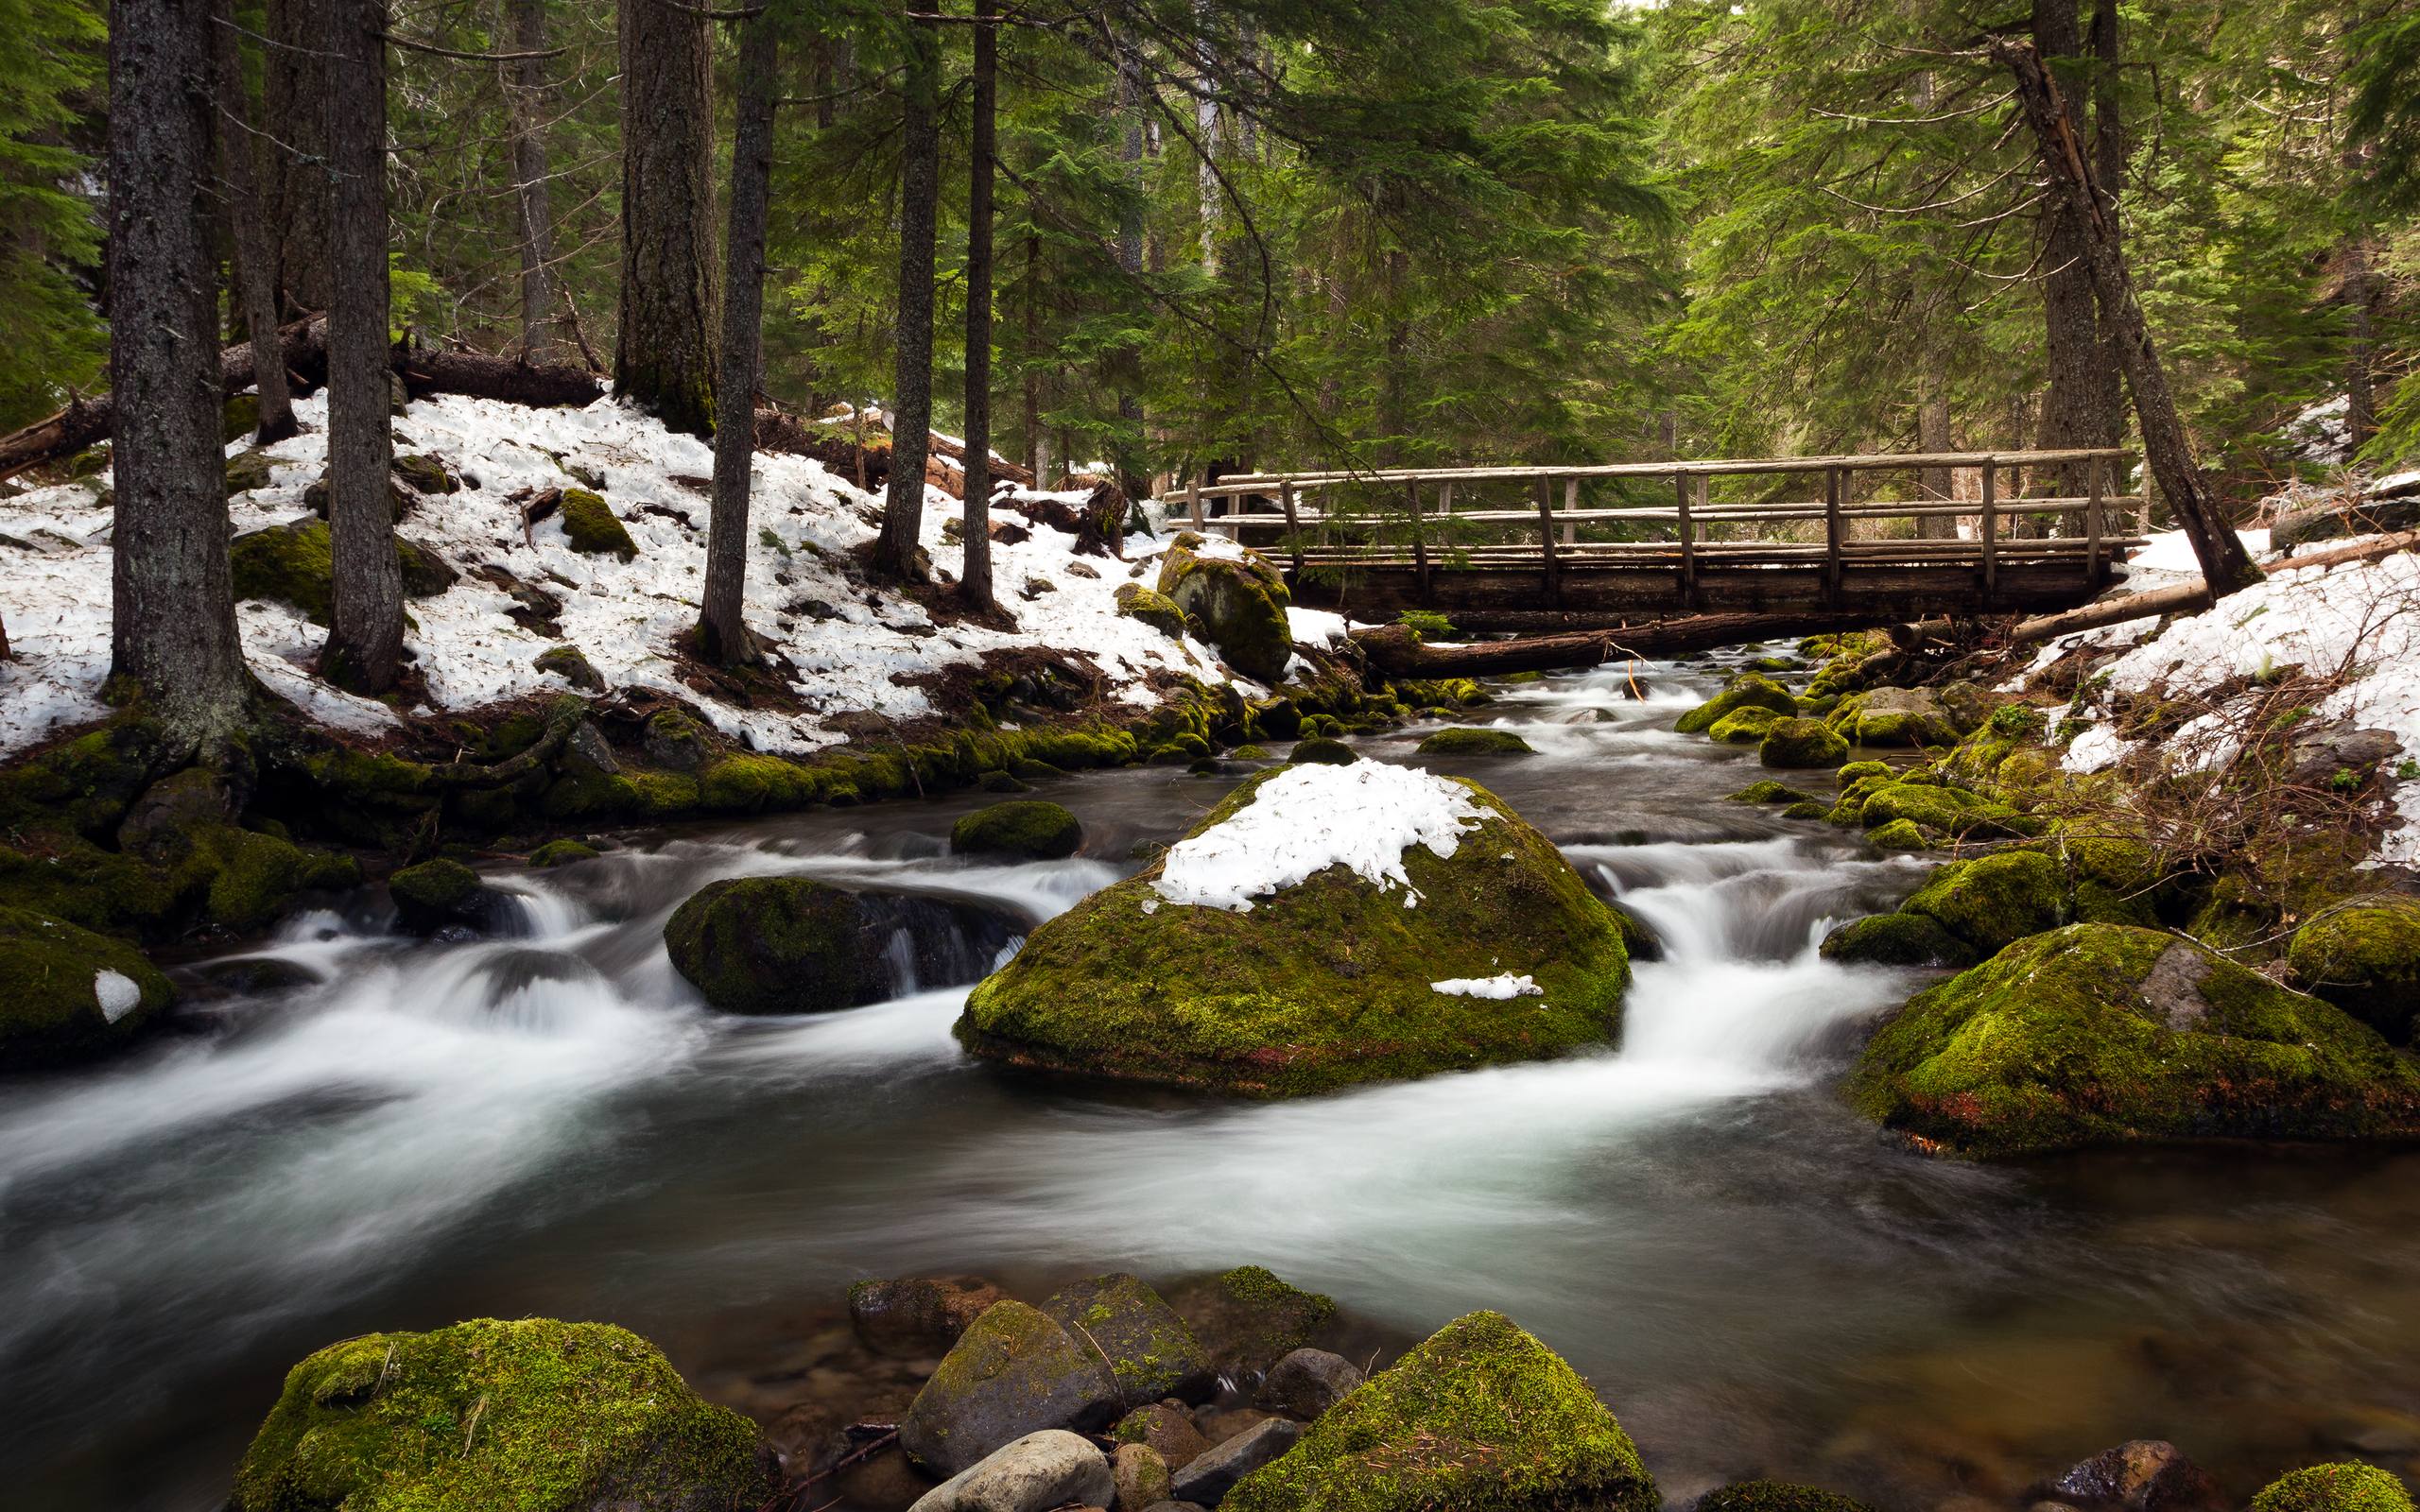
[0,907,174,1072]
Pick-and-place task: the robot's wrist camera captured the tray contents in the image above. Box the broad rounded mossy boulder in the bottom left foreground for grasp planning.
[228,1318,774,1512]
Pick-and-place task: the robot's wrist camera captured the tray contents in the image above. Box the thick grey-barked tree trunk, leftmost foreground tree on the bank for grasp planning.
[109,0,251,752]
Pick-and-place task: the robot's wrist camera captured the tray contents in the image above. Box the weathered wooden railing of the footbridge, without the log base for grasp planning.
[1162,448,2147,600]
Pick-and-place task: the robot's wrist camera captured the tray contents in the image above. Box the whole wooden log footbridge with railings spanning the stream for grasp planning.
[1162,448,2144,619]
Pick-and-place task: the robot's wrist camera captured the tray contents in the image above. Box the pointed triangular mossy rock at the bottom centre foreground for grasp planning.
[1219,1314,1658,1512]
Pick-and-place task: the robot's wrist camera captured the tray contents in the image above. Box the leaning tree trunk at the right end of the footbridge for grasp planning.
[1989,39,2260,597]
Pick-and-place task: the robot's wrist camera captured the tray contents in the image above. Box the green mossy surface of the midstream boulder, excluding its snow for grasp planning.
[956,774,1629,1096]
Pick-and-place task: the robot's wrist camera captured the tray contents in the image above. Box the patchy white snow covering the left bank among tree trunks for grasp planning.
[0,397,1268,755]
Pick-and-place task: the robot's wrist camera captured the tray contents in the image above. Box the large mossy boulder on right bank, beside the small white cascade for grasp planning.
[1846,924,2420,1157]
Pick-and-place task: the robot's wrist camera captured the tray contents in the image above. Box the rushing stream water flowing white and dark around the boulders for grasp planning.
[0,668,2420,1512]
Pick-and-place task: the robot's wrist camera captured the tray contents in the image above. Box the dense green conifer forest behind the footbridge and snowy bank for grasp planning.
[0,0,2420,498]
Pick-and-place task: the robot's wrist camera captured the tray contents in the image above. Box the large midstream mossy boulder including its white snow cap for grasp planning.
[956,762,1629,1096]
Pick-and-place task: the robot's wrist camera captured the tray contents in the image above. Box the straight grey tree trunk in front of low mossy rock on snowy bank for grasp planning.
[320,0,405,695]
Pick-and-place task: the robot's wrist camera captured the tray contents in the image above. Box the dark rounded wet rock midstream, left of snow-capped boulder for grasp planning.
[663,876,883,1014]
